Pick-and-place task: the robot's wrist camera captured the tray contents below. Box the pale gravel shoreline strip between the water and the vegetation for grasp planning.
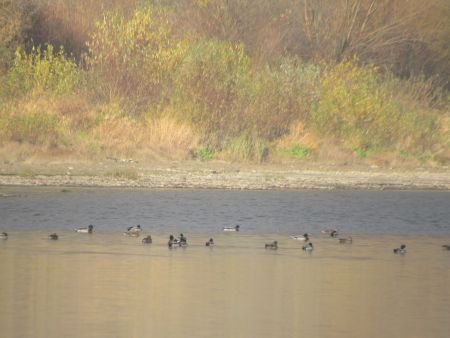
[0,163,450,191]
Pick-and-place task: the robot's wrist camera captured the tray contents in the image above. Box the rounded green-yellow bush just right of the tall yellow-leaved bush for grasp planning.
[171,40,250,144]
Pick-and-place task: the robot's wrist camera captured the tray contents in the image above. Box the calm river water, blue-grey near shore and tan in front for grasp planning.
[0,188,450,337]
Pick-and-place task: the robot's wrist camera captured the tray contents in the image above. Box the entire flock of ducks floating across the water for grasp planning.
[0,224,450,254]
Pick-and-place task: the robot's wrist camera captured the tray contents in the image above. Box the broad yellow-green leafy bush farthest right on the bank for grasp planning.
[309,61,437,150]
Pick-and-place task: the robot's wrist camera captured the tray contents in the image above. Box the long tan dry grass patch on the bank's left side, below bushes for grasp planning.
[0,95,200,161]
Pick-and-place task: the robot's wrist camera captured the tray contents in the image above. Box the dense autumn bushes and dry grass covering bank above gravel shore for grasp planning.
[0,0,450,164]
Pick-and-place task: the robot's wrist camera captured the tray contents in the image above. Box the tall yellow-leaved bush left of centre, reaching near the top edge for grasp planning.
[86,5,183,109]
